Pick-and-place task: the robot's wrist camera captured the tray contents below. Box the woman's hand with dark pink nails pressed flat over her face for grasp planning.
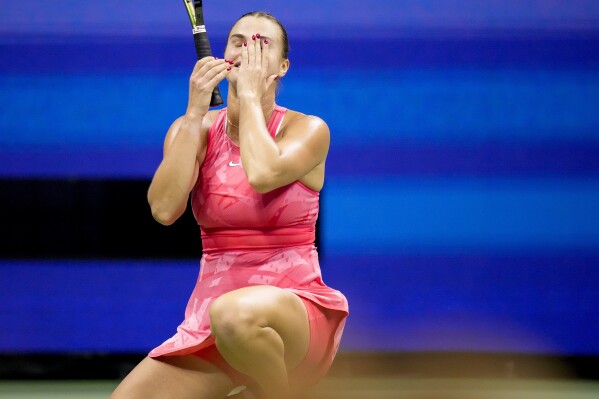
[237,33,278,98]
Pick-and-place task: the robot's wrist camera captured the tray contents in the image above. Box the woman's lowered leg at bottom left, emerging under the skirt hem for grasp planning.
[110,355,233,399]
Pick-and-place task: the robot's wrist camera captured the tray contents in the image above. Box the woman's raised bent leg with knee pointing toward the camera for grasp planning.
[210,286,310,399]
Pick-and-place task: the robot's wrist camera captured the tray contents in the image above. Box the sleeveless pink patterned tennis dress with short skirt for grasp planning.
[149,106,348,386]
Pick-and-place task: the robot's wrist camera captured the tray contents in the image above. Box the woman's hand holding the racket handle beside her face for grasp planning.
[186,56,231,119]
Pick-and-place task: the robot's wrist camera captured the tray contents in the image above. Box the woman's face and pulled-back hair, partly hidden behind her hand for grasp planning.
[225,16,289,82]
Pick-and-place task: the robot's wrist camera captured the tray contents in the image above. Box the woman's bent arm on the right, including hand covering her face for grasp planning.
[237,36,330,193]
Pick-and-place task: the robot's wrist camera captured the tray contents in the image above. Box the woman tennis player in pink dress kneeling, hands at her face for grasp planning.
[111,12,348,399]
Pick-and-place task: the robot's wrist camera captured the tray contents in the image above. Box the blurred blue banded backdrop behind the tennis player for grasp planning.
[0,0,599,355]
